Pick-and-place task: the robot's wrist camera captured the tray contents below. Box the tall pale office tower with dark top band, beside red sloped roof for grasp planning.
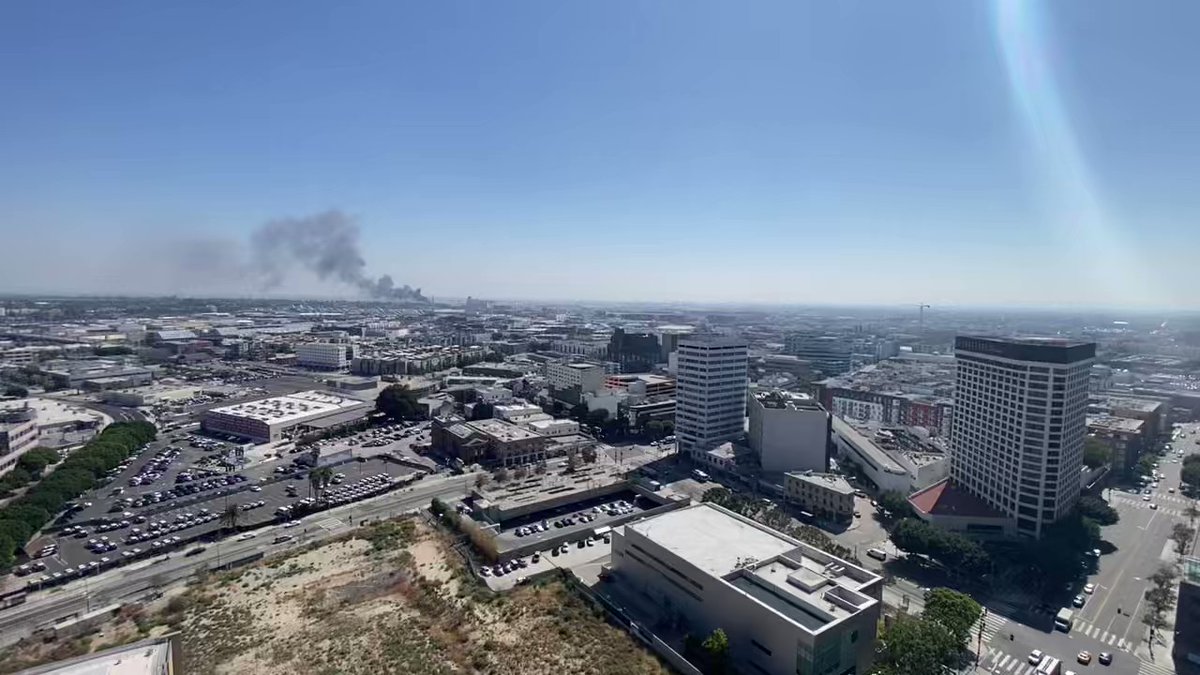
[950,336,1096,537]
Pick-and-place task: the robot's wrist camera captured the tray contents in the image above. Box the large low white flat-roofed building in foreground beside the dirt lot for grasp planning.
[612,503,883,675]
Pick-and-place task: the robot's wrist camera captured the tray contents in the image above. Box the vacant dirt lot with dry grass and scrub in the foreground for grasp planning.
[0,520,667,675]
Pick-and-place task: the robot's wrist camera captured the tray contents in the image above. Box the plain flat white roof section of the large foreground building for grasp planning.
[626,503,796,577]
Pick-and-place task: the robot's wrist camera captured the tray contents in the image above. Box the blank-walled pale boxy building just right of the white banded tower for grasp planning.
[746,392,830,473]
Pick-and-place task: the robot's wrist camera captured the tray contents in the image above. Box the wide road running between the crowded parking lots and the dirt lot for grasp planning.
[0,473,475,647]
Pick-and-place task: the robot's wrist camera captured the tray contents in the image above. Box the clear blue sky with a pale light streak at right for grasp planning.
[0,0,1200,309]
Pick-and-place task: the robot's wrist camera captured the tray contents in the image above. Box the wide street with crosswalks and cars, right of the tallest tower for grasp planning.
[980,425,1200,675]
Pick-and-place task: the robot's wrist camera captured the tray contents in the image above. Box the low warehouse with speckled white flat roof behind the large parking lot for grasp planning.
[200,392,371,443]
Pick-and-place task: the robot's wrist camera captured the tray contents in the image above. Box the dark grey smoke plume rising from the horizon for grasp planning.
[251,210,428,301]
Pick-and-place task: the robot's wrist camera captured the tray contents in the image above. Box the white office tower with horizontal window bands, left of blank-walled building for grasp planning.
[676,335,749,453]
